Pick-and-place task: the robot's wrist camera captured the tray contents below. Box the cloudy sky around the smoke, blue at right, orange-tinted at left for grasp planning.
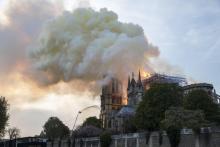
[0,0,220,136]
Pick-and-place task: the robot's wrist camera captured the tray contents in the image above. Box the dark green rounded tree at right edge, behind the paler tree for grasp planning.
[183,90,220,123]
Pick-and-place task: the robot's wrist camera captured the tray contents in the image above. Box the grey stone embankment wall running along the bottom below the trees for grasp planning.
[47,131,220,147]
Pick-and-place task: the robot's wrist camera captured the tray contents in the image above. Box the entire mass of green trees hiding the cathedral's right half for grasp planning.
[135,83,220,147]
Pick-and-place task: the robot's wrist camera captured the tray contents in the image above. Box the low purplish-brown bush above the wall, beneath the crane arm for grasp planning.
[73,125,102,137]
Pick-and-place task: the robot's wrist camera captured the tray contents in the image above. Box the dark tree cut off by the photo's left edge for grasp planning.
[0,97,9,138]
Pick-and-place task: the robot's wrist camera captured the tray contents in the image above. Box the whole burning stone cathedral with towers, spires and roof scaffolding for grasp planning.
[100,71,220,132]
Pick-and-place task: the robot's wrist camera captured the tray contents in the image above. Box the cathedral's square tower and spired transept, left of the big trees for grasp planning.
[100,72,144,131]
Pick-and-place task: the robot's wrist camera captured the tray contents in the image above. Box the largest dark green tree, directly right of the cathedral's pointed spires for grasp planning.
[135,83,183,131]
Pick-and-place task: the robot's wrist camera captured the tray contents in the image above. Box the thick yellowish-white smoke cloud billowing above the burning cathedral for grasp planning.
[30,8,159,91]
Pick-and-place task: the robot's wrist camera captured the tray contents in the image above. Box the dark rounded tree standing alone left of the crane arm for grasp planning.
[42,117,70,139]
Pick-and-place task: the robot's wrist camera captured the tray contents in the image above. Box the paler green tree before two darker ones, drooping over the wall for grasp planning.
[161,107,207,147]
